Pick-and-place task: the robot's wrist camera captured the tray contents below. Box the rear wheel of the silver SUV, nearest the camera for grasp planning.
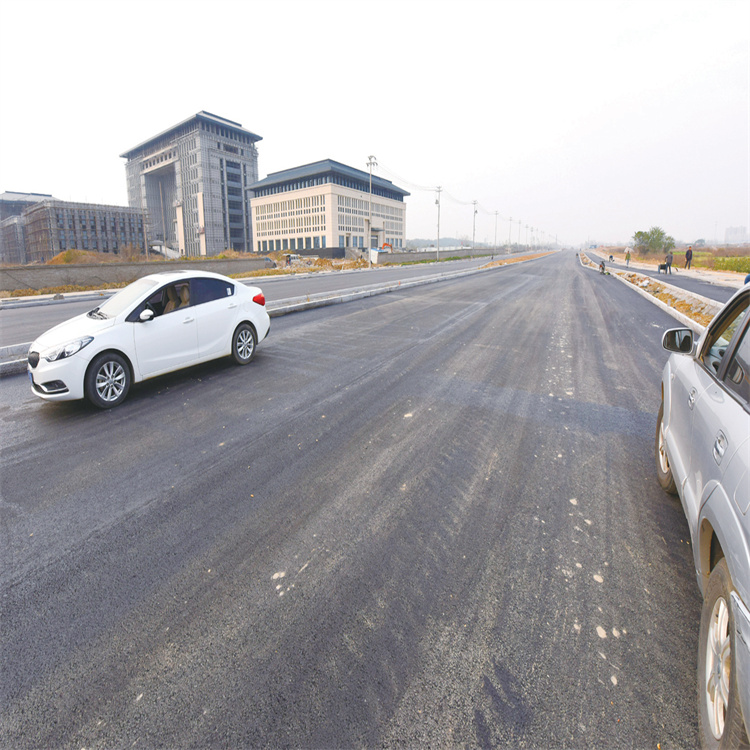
[698,558,748,749]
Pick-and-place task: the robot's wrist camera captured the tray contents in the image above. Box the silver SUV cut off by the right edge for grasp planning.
[656,284,750,748]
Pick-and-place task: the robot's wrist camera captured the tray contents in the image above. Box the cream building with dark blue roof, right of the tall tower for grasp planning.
[250,159,409,258]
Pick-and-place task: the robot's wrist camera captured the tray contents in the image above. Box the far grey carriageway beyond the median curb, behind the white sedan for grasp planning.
[0,256,490,347]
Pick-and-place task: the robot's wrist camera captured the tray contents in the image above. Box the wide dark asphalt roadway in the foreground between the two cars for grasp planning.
[0,252,700,748]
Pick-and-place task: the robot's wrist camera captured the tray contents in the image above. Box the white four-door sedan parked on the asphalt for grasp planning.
[28,271,270,409]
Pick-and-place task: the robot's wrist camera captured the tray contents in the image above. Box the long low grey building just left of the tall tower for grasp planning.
[21,200,146,263]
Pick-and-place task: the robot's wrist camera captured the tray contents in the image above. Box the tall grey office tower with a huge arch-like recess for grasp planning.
[121,112,261,256]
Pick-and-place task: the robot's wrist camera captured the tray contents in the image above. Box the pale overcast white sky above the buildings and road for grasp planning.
[0,0,750,245]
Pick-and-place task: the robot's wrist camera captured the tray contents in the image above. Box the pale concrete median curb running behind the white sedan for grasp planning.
[0,256,546,378]
